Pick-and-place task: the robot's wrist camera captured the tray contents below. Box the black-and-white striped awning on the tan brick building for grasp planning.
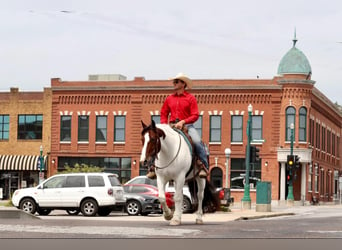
[0,155,47,171]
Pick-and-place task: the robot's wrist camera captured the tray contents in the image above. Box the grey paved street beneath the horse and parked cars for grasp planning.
[0,205,342,239]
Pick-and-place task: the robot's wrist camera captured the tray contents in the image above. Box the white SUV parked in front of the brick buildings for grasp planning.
[12,173,126,216]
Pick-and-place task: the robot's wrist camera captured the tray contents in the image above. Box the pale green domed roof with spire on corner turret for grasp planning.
[278,33,311,75]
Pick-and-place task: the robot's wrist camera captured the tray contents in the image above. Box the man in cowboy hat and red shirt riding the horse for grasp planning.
[147,73,209,179]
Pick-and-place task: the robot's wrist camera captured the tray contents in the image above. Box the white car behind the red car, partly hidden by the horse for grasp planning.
[125,175,194,213]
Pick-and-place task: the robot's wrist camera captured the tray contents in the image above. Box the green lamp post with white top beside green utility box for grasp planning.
[241,104,253,209]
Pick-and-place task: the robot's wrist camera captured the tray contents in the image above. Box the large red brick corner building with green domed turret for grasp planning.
[51,39,342,205]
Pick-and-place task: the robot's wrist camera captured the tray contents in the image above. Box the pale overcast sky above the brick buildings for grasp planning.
[0,0,342,104]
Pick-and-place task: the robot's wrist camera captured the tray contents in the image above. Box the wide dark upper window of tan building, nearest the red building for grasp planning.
[18,115,43,140]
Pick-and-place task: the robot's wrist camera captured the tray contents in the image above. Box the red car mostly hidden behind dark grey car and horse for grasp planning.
[123,184,175,208]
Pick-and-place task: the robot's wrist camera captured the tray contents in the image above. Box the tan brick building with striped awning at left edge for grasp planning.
[0,88,51,199]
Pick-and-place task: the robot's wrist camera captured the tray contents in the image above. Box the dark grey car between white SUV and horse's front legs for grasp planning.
[124,193,162,215]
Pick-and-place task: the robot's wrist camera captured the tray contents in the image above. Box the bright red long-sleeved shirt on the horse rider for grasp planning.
[160,91,199,124]
